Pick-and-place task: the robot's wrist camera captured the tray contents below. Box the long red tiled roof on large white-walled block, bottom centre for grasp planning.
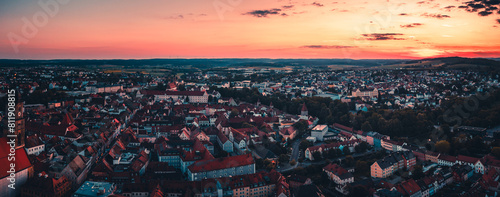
[188,154,255,172]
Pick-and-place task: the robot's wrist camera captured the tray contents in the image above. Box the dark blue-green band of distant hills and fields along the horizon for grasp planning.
[0,57,500,70]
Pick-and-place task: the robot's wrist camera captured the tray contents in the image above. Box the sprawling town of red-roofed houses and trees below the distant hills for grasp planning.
[0,62,500,197]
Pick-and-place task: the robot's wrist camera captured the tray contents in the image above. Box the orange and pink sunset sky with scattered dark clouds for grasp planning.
[0,0,500,59]
